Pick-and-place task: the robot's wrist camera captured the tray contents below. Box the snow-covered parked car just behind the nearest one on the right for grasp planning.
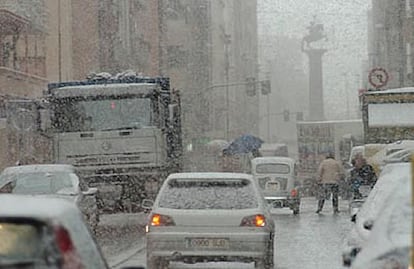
[342,163,411,266]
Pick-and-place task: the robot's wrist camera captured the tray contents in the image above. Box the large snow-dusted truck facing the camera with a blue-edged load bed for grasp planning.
[5,73,183,212]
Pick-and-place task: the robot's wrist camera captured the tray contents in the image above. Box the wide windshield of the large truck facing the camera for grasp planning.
[53,98,153,132]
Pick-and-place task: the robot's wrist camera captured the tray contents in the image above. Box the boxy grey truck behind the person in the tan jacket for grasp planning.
[296,119,363,194]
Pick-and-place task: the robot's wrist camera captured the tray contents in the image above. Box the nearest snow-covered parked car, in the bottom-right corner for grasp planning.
[352,166,413,269]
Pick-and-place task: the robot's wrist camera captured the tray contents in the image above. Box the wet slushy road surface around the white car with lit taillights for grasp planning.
[100,197,352,269]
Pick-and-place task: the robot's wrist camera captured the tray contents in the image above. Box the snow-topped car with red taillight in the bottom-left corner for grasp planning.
[0,194,109,269]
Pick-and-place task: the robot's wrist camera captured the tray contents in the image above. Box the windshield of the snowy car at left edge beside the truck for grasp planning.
[0,172,77,194]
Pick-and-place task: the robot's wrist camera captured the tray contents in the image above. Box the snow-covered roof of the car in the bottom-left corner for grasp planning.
[0,194,81,221]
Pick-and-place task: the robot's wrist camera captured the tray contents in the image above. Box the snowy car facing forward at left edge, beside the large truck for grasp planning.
[0,164,99,230]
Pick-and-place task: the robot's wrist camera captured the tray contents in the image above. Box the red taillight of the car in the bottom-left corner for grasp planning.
[54,226,84,269]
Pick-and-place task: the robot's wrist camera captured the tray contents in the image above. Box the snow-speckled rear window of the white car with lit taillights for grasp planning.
[159,179,258,210]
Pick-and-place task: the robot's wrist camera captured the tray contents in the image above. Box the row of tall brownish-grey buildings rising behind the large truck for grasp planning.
[0,0,260,165]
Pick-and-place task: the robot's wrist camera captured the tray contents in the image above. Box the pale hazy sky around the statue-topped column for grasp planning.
[258,0,371,118]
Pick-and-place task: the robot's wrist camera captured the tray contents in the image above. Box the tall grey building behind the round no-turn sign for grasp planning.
[367,0,414,88]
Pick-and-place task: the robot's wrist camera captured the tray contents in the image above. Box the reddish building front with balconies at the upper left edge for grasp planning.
[0,9,46,96]
